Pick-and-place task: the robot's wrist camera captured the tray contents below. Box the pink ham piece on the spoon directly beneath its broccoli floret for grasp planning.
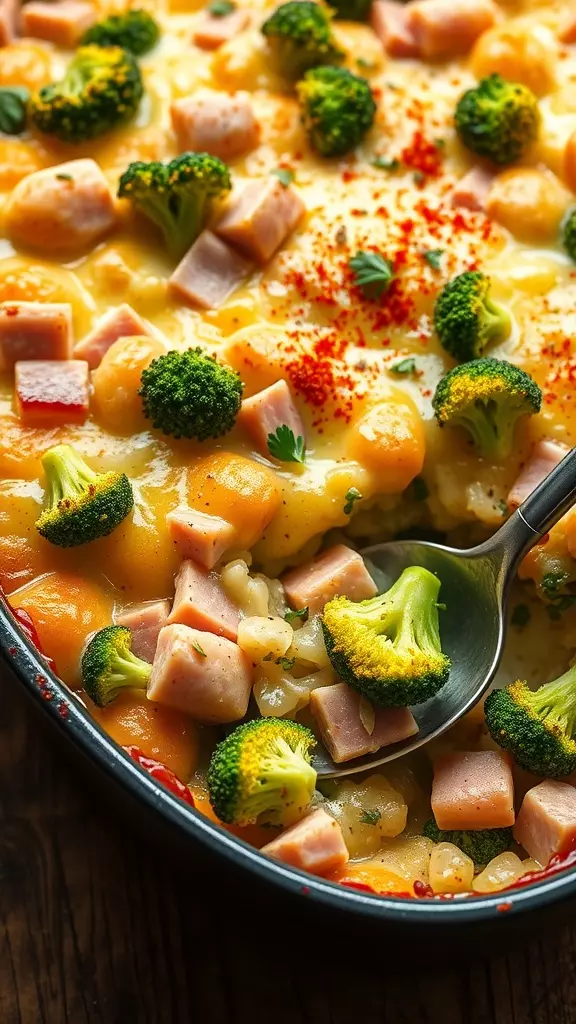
[310,683,418,764]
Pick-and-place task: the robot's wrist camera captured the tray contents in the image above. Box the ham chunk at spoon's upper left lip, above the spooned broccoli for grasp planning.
[282,544,377,616]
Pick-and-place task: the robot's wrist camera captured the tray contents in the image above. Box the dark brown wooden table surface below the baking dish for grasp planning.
[0,679,576,1024]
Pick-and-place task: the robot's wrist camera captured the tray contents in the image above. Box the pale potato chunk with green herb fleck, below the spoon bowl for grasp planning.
[327,774,408,857]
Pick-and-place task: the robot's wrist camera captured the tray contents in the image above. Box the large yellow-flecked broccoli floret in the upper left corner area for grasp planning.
[30,46,143,142]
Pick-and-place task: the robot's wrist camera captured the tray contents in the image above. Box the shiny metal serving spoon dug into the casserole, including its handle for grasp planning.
[315,449,576,777]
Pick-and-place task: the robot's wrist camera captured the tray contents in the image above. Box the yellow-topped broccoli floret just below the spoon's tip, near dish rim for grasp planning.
[208,718,316,825]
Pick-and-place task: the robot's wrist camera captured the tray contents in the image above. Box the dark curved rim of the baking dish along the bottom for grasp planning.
[0,595,576,926]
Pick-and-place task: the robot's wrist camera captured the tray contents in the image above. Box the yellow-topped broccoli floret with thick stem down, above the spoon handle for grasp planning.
[433,358,542,459]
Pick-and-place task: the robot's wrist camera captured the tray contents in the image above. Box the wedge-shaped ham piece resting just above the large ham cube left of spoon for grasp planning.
[168,558,240,640]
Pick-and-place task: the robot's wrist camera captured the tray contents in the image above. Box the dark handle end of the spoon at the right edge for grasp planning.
[493,449,576,564]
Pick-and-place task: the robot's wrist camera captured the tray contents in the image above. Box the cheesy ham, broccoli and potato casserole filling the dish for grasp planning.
[0,0,576,898]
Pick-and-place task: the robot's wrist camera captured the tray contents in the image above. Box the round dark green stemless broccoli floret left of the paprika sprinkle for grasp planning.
[138,348,243,441]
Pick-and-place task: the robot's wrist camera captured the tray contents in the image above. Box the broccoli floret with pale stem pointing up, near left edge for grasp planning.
[36,444,134,548]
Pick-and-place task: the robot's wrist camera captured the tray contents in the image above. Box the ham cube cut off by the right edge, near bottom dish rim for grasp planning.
[513,778,576,867]
